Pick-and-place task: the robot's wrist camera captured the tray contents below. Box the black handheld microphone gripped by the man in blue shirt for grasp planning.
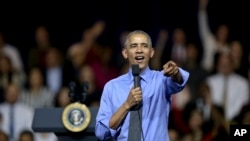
[132,64,142,110]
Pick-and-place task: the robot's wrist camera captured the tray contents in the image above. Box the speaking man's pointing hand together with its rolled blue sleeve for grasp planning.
[163,61,189,94]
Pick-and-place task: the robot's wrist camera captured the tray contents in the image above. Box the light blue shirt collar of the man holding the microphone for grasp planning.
[127,66,151,83]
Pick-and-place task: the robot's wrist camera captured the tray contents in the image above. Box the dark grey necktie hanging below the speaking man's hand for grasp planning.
[128,77,142,141]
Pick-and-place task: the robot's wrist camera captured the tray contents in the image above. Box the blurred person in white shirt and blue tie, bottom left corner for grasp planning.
[0,83,34,141]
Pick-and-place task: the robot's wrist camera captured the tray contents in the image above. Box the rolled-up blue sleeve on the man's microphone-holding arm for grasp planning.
[95,83,120,140]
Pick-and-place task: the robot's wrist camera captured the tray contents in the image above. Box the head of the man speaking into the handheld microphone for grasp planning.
[122,34,154,70]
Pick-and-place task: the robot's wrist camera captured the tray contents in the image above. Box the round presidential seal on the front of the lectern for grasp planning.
[62,102,91,132]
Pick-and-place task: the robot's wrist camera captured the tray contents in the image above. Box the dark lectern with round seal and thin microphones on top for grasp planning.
[32,84,98,141]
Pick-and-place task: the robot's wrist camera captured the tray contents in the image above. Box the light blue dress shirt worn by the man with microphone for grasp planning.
[95,67,189,141]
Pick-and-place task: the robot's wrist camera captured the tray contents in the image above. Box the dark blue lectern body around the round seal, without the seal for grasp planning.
[32,107,98,141]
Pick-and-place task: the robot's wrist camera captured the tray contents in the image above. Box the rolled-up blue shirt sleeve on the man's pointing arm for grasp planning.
[166,68,189,94]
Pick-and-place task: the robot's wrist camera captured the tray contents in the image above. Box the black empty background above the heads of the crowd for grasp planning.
[0,0,250,64]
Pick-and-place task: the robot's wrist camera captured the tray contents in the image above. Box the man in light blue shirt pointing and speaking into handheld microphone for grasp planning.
[95,30,189,141]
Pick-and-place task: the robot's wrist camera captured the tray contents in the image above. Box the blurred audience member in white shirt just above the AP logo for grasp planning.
[207,53,249,122]
